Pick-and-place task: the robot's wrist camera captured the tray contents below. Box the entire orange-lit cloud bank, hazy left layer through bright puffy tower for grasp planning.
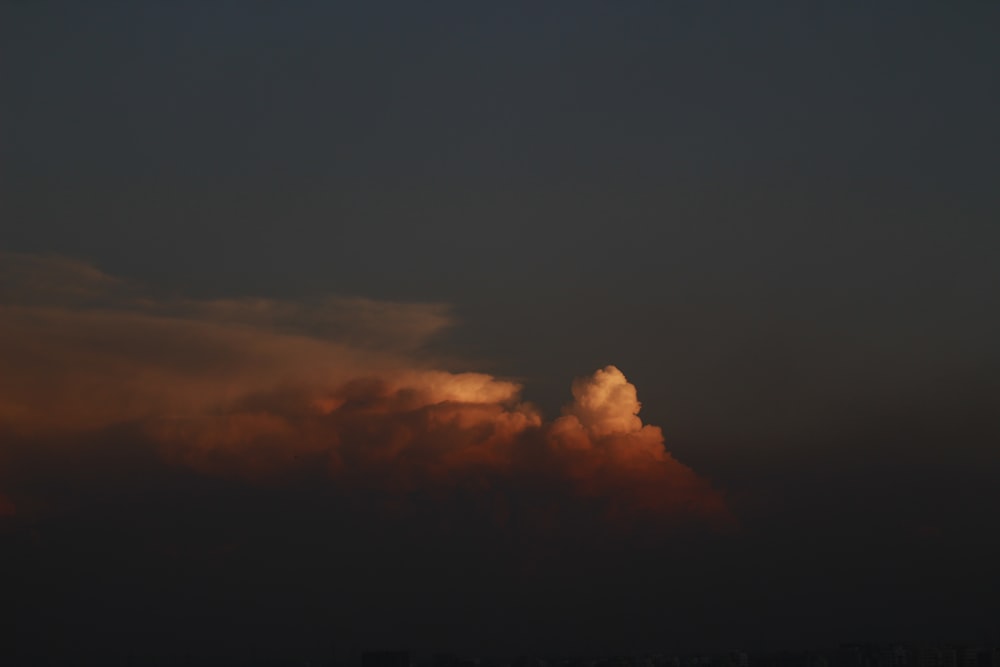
[0,256,728,521]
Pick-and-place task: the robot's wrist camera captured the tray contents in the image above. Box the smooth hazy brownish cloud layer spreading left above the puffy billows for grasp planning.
[0,253,452,433]
